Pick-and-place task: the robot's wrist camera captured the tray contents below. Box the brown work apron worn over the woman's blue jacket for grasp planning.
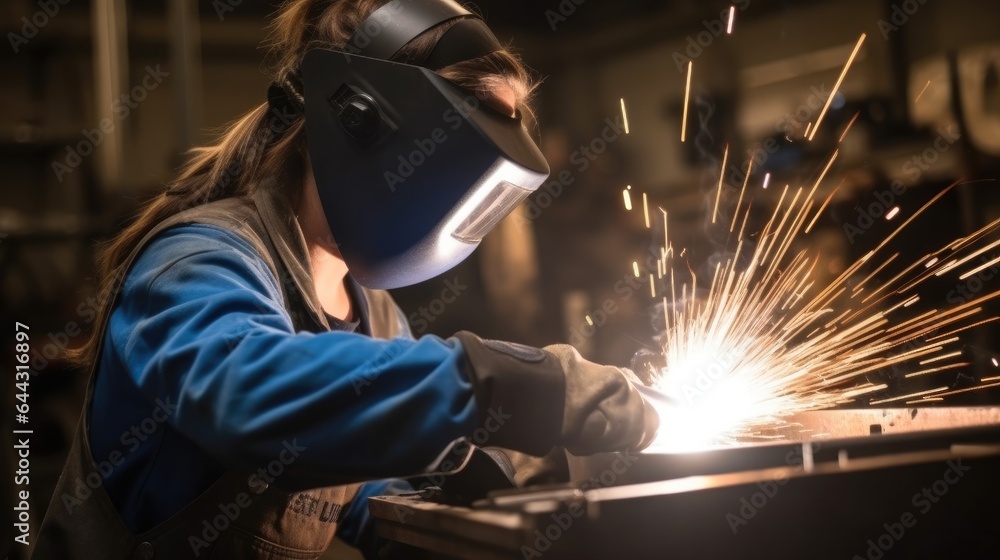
[33,182,406,560]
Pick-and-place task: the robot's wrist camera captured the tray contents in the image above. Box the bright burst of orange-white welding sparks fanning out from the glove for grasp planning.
[633,166,1000,450]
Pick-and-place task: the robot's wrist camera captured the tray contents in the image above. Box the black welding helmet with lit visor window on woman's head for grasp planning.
[300,0,549,289]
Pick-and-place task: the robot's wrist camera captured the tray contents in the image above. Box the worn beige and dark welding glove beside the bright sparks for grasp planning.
[455,332,659,456]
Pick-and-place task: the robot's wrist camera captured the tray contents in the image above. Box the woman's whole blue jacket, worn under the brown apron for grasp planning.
[90,225,478,544]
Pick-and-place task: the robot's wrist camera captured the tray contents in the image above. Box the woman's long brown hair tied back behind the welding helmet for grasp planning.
[67,0,534,366]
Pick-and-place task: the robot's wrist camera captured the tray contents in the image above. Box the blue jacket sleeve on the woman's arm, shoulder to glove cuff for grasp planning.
[110,225,477,490]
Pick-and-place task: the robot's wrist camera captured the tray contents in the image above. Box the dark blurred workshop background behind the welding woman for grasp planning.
[0,0,1000,556]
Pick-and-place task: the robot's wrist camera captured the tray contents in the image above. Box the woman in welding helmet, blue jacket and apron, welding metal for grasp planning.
[35,0,657,559]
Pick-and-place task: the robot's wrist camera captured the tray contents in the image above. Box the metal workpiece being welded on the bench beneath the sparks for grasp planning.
[371,408,1000,560]
